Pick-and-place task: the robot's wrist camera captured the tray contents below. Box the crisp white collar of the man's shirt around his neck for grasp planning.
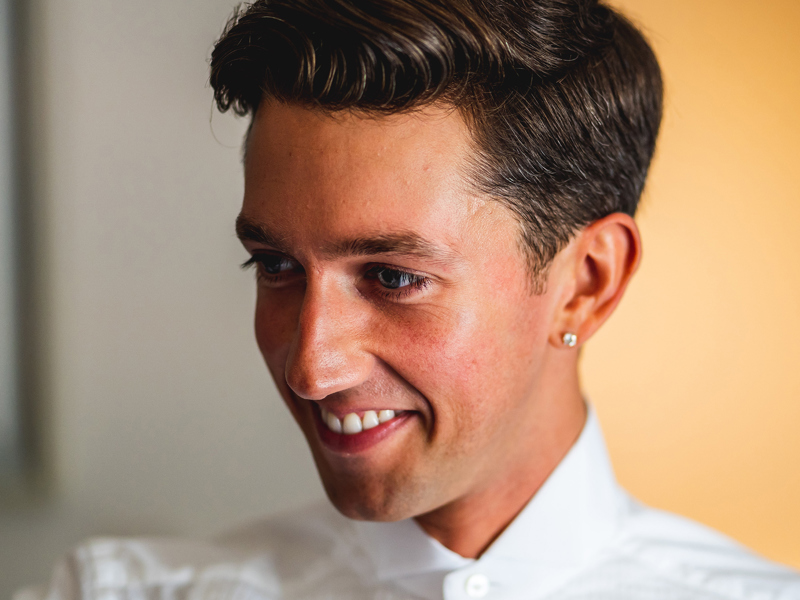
[354,407,625,598]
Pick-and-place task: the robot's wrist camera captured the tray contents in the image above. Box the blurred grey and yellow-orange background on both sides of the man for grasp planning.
[0,0,800,598]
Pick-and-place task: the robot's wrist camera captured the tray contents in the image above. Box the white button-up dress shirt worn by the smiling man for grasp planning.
[16,411,800,600]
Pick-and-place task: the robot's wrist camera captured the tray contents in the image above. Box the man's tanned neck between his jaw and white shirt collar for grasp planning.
[415,377,586,558]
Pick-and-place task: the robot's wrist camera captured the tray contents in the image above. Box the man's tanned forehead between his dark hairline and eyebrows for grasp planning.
[242,102,483,247]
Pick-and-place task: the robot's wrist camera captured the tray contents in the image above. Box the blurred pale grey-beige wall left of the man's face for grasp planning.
[0,0,322,598]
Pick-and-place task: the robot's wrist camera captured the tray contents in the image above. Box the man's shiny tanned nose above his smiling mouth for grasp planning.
[285,282,375,400]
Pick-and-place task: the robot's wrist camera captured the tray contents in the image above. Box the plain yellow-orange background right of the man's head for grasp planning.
[582,0,800,567]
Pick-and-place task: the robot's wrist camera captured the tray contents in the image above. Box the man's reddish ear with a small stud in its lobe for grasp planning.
[549,213,642,349]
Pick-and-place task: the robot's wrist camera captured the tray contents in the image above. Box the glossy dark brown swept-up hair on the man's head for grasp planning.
[211,0,663,282]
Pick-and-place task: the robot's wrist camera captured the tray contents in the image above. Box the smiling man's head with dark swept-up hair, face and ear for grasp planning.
[211,0,661,540]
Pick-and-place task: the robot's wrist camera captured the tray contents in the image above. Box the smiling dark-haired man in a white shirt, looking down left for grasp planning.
[21,0,800,600]
